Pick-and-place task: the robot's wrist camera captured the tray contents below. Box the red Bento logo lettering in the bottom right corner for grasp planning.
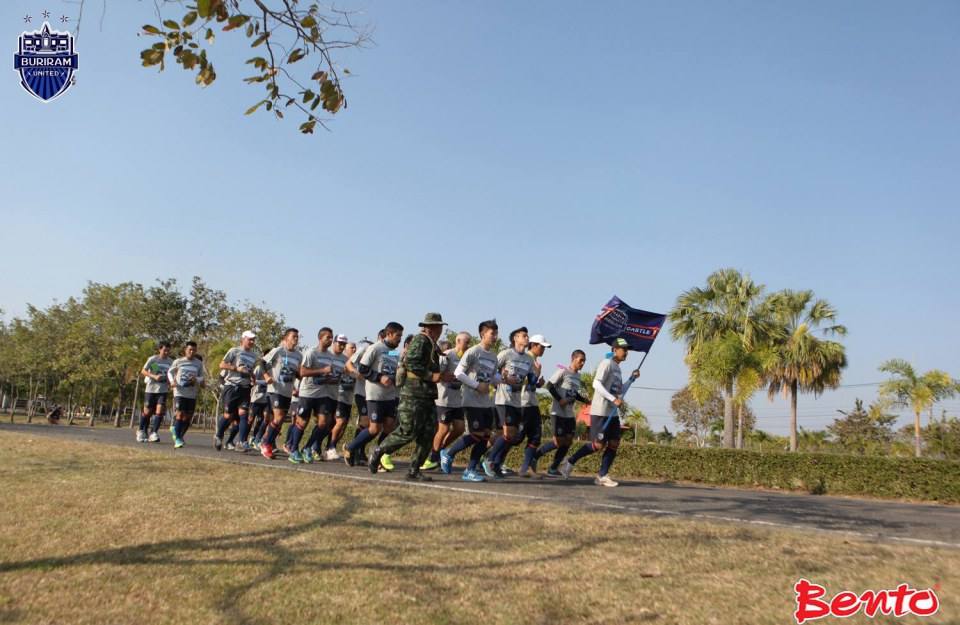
[793,579,940,625]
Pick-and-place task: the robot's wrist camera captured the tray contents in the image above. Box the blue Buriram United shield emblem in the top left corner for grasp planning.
[13,22,77,102]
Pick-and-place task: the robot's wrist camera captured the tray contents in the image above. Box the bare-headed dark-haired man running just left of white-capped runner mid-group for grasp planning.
[298,328,345,464]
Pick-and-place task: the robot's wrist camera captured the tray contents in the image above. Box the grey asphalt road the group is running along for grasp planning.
[0,423,960,548]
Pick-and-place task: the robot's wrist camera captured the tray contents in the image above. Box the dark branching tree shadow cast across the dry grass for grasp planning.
[0,493,612,625]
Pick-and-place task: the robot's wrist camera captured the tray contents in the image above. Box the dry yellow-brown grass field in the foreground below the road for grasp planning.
[0,433,960,625]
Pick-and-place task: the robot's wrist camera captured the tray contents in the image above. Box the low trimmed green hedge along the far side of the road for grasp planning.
[498,442,960,503]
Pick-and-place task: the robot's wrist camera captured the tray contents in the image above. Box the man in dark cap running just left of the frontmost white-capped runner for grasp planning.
[483,327,534,480]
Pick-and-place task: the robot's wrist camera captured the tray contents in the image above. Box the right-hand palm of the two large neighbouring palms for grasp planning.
[766,290,847,451]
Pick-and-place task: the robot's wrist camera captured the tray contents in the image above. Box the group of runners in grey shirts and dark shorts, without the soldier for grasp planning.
[136,316,638,486]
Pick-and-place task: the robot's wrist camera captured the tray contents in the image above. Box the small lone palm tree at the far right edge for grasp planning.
[880,358,960,458]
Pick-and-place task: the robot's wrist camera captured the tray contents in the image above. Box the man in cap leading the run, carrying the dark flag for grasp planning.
[560,339,640,487]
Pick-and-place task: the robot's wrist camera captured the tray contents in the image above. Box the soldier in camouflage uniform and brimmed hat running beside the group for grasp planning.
[367,313,453,481]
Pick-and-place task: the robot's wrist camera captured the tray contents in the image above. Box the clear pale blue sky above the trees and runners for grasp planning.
[0,0,960,434]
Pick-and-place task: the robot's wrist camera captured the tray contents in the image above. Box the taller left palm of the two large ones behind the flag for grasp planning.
[668,269,774,447]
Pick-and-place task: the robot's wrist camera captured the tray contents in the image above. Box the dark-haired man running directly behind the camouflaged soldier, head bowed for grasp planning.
[344,321,403,471]
